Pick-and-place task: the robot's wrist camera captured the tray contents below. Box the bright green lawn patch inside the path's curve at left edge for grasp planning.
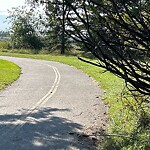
[0,59,21,90]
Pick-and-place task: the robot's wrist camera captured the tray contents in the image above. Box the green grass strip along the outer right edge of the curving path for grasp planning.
[0,52,148,150]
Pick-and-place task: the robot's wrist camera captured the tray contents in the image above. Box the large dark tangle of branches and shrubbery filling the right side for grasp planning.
[65,0,150,149]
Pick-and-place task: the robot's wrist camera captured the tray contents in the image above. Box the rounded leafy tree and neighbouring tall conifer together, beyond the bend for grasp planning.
[7,1,73,54]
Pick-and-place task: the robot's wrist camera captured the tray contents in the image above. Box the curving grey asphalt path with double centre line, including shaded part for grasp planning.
[0,56,106,150]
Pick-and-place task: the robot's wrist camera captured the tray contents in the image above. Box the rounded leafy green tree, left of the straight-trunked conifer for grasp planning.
[8,7,42,50]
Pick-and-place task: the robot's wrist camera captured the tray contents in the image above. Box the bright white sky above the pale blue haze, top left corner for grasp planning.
[0,0,25,15]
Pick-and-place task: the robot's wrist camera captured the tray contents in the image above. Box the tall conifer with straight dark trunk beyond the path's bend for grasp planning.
[28,0,71,54]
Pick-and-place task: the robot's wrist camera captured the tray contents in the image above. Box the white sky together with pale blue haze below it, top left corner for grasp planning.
[0,0,25,30]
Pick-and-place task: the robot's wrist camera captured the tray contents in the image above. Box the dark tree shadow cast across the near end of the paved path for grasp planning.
[0,107,94,150]
